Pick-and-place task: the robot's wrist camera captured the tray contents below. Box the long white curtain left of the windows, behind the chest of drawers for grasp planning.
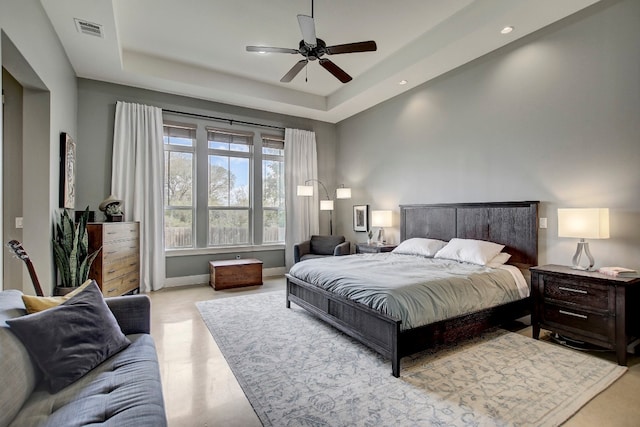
[111,101,165,292]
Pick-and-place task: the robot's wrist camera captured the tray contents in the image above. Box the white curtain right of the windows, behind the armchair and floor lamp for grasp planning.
[284,129,320,271]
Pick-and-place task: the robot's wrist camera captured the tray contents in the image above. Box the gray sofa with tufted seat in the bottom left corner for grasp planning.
[0,290,167,427]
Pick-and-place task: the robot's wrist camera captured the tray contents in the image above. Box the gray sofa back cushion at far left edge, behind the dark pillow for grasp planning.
[0,290,42,427]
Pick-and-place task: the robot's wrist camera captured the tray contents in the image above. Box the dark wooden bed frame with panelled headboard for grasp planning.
[286,202,539,377]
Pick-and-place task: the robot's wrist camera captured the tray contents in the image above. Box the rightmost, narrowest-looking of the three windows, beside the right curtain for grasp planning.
[262,135,285,243]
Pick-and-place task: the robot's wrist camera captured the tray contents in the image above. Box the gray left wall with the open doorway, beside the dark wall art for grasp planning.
[0,0,77,293]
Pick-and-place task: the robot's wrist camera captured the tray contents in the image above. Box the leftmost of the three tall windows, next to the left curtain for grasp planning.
[164,123,196,249]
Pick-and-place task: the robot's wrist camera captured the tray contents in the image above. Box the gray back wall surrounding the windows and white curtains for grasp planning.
[76,79,338,278]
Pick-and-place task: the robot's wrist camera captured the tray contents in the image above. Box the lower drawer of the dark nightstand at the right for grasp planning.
[543,304,614,338]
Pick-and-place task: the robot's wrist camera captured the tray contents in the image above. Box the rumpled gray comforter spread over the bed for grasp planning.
[289,253,522,330]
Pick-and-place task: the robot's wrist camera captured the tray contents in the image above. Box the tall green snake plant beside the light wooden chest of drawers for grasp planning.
[53,206,100,295]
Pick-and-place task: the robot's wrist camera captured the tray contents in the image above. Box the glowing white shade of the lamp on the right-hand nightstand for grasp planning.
[558,208,609,239]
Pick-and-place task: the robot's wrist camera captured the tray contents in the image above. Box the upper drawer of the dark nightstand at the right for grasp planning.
[544,276,609,310]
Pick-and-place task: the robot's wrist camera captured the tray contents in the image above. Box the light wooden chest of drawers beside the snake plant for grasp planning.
[87,222,140,297]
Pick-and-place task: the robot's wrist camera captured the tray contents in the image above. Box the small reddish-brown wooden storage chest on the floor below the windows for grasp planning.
[209,259,262,291]
